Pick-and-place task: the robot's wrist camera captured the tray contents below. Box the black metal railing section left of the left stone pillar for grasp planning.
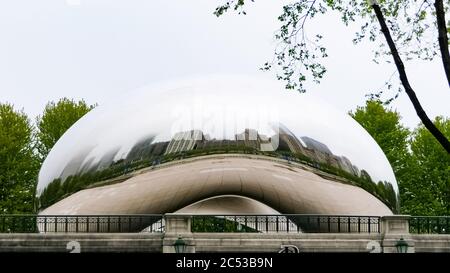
[0,214,165,233]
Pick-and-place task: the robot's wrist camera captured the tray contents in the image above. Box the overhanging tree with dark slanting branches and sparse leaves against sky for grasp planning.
[215,0,450,153]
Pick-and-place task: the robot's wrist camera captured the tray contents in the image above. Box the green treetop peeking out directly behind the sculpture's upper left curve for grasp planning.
[36,98,95,159]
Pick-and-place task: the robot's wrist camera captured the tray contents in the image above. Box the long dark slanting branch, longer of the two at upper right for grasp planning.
[370,0,450,154]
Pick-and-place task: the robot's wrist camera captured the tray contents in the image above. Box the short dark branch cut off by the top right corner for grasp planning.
[434,0,450,85]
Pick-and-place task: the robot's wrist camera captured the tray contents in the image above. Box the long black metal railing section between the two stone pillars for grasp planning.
[191,214,380,233]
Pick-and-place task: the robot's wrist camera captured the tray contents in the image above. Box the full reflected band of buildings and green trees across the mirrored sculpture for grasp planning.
[40,124,398,211]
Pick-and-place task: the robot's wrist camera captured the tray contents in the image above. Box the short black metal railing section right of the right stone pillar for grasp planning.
[409,216,450,234]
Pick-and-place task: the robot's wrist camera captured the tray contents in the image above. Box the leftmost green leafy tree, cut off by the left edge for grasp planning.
[0,103,39,214]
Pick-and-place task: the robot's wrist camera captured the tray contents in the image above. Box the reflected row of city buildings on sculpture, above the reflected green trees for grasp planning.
[60,124,367,180]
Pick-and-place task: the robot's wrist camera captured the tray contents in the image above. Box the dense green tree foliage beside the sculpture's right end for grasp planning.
[350,101,450,215]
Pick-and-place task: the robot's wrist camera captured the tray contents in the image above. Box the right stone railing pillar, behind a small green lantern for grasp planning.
[381,215,415,253]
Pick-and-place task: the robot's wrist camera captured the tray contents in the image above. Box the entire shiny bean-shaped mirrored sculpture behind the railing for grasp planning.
[37,76,399,215]
